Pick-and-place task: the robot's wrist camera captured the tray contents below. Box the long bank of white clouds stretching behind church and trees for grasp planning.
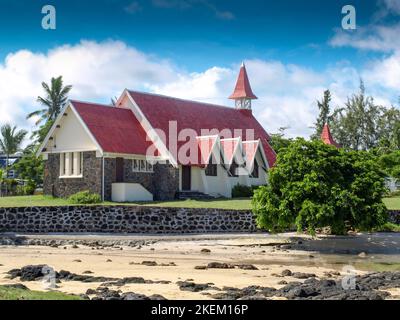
[0,41,400,142]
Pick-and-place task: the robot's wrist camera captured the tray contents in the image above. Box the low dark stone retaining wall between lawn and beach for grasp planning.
[0,206,257,234]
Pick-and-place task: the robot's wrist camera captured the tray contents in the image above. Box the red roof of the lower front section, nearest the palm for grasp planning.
[71,101,158,155]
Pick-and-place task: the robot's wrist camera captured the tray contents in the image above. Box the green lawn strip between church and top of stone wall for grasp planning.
[0,196,251,210]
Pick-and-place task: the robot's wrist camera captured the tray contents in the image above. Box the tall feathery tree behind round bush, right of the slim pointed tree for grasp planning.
[330,80,385,150]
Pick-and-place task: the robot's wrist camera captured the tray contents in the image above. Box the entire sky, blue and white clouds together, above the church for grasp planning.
[0,0,400,135]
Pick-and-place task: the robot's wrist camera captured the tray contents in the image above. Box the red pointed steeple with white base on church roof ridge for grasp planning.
[229,62,258,110]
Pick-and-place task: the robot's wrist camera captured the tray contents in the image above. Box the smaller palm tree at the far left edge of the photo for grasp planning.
[0,124,28,193]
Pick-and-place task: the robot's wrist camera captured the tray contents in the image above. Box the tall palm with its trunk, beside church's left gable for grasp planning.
[27,76,72,143]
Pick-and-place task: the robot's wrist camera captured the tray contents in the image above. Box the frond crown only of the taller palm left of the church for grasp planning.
[27,76,72,125]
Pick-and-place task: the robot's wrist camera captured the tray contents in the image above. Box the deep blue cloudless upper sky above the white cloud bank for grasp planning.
[0,0,384,71]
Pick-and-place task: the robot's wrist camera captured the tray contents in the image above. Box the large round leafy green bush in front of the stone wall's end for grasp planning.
[252,139,388,234]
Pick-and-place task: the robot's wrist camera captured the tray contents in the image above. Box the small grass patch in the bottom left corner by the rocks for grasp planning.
[0,286,82,300]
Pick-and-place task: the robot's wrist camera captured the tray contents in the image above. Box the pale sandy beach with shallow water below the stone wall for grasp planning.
[0,234,400,300]
